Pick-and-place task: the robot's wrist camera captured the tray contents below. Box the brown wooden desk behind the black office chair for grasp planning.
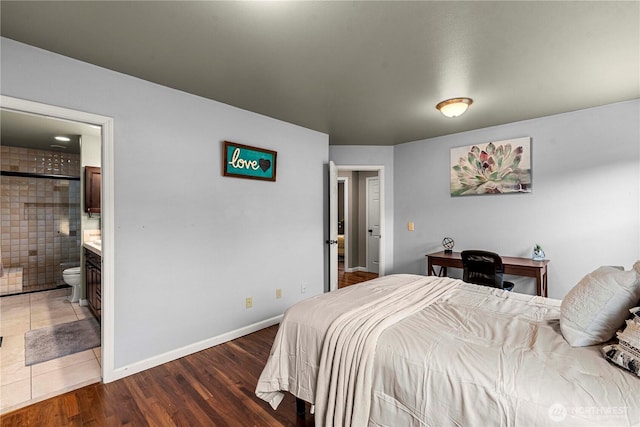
[427,251,549,297]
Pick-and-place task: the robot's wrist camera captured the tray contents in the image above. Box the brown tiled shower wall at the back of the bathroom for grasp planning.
[0,145,81,292]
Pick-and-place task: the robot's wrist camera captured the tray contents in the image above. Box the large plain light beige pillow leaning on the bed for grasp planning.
[560,262,640,347]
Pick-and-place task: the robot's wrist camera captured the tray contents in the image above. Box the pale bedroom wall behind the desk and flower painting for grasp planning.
[394,100,640,298]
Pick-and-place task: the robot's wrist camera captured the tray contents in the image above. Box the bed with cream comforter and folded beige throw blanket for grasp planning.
[256,272,640,426]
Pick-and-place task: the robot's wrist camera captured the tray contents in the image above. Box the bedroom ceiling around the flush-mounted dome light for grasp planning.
[0,0,640,145]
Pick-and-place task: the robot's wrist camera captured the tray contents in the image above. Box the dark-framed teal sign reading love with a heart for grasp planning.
[222,141,278,181]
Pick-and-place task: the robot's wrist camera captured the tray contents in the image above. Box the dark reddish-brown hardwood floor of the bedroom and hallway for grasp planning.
[0,269,377,427]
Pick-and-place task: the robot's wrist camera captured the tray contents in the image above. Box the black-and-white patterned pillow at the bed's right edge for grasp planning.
[602,308,640,377]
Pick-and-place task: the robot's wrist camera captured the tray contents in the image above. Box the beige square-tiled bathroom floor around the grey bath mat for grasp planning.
[0,288,101,414]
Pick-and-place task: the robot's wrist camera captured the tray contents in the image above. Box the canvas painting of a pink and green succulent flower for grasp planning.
[450,137,531,196]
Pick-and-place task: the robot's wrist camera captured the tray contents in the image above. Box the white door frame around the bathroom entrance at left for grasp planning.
[0,95,118,383]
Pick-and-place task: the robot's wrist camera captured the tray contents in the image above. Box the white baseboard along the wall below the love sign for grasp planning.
[103,314,283,383]
